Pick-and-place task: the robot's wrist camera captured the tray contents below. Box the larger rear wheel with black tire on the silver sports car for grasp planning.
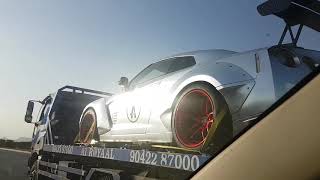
[171,83,233,154]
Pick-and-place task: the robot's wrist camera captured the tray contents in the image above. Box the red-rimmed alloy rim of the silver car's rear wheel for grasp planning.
[174,89,215,148]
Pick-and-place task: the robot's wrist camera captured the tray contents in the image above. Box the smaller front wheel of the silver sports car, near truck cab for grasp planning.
[79,108,97,145]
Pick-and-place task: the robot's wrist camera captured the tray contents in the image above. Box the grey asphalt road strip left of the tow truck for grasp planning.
[0,148,29,180]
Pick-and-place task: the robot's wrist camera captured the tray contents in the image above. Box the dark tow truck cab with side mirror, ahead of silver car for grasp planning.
[25,86,110,166]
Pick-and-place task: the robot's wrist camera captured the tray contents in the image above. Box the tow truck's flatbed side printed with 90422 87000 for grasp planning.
[37,144,210,179]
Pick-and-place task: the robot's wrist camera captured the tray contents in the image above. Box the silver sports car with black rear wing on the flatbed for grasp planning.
[79,0,320,150]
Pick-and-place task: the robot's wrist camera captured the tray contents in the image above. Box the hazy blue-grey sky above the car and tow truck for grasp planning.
[0,0,320,138]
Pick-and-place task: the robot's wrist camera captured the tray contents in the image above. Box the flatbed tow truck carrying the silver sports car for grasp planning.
[25,86,210,180]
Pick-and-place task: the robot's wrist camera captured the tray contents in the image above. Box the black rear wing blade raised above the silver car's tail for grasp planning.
[257,0,320,32]
